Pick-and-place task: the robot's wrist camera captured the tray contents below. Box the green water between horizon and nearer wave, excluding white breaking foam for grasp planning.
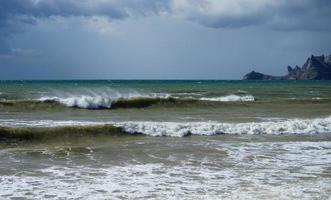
[0,81,331,122]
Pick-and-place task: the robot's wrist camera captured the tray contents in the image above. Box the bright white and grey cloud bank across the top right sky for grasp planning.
[172,0,331,30]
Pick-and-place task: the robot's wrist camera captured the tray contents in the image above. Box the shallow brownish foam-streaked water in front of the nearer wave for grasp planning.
[0,135,331,199]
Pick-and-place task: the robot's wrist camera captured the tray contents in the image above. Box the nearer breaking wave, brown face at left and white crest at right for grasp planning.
[0,116,331,138]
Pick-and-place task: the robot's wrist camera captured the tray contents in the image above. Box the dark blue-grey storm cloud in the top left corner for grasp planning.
[0,0,167,36]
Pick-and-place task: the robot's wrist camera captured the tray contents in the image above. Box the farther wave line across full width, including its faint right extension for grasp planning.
[0,94,331,109]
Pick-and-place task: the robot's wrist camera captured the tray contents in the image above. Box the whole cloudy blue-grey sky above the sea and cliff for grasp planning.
[0,0,331,80]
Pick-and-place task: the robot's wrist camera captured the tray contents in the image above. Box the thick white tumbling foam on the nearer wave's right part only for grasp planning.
[114,117,331,137]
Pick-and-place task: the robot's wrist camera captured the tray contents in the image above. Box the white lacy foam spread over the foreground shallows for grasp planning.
[0,140,331,199]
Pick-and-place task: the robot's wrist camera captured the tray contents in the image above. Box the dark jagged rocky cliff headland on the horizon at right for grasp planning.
[243,55,331,80]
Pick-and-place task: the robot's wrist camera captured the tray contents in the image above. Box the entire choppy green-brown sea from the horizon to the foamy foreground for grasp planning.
[0,80,331,199]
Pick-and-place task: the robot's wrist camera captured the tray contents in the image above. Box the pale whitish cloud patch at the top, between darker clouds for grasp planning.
[172,0,275,28]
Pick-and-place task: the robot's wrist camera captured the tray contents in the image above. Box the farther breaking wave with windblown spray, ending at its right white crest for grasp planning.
[0,94,255,109]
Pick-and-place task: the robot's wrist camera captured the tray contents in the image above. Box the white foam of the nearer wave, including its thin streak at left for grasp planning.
[0,116,331,137]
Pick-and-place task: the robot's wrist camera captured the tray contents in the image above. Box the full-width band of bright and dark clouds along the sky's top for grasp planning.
[0,0,331,35]
